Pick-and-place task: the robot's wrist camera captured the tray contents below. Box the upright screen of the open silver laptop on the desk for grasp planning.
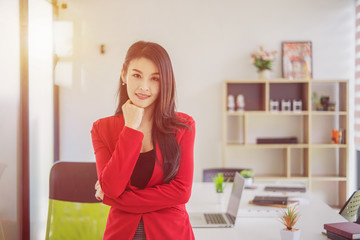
[226,172,245,217]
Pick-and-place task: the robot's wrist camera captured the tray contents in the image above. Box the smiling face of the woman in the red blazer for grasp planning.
[121,58,160,108]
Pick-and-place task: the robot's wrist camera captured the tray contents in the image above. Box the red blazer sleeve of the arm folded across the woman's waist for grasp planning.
[103,121,195,213]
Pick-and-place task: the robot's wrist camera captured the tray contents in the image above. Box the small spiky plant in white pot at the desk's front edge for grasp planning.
[280,207,301,240]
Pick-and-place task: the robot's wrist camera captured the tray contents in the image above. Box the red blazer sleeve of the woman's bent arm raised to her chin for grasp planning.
[91,120,144,198]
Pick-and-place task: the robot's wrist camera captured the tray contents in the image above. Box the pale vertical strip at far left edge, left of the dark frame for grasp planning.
[0,0,20,240]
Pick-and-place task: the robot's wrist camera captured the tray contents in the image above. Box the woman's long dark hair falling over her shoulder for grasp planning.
[115,41,189,183]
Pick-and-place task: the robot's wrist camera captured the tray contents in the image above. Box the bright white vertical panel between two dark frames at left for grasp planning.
[29,0,54,240]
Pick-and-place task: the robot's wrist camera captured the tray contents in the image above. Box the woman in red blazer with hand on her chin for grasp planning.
[91,41,195,240]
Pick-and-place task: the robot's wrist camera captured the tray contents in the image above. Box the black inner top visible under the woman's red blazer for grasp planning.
[130,149,155,188]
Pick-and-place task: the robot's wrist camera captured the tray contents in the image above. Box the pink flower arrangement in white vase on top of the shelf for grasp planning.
[250,46,277,72]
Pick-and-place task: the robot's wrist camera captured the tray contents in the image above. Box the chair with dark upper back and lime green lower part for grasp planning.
[45,161,110,240]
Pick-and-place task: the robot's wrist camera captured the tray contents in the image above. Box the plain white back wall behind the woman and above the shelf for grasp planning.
[60,0,355,186]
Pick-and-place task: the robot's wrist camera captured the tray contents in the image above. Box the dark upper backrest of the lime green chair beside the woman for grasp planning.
[49,161,99,203]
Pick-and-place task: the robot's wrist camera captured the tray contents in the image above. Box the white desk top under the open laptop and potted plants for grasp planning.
[186,183,346,240]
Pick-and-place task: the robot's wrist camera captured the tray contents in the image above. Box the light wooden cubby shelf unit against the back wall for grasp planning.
[223,79,348,206]
